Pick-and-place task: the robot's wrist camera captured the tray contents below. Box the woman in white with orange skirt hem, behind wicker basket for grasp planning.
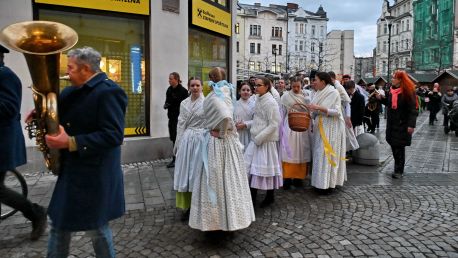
[280,77,311,190]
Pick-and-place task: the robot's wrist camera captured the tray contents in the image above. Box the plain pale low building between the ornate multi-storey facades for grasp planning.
[321,30,355,78]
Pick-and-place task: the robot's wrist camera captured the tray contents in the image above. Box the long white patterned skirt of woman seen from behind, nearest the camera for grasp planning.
[189,134,255,231]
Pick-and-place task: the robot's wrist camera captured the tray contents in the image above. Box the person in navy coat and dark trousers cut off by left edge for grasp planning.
[0,45,47,240]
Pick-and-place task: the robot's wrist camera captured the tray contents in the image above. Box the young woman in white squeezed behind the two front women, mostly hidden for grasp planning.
[234,82,255,148]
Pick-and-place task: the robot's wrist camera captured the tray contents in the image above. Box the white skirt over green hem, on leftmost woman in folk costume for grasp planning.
[173,128,204,192]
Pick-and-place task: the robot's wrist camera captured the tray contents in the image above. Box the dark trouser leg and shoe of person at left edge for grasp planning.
[0,172,41,221]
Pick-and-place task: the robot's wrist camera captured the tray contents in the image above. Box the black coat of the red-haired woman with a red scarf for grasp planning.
[382,88,418,147]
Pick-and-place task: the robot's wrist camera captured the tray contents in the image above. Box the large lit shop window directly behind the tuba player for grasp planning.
[38,9,149,136]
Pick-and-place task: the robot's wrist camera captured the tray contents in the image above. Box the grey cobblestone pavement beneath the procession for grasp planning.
[0,114,458,257]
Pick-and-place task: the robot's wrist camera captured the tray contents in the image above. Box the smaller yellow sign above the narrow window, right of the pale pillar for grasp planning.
[192,0,232,36]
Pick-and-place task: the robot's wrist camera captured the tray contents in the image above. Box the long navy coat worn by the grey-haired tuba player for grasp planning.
[48,73,127,231]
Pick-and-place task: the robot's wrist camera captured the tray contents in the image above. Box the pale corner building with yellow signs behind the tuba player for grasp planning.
[0,0,237,171]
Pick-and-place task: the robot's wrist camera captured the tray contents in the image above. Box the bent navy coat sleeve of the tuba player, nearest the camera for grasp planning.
[75,87,127,157]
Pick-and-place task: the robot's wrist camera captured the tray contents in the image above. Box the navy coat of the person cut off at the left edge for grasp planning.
[0,62,27,172]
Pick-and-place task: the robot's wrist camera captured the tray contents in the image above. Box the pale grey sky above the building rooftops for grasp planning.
[239,0,383,56]
